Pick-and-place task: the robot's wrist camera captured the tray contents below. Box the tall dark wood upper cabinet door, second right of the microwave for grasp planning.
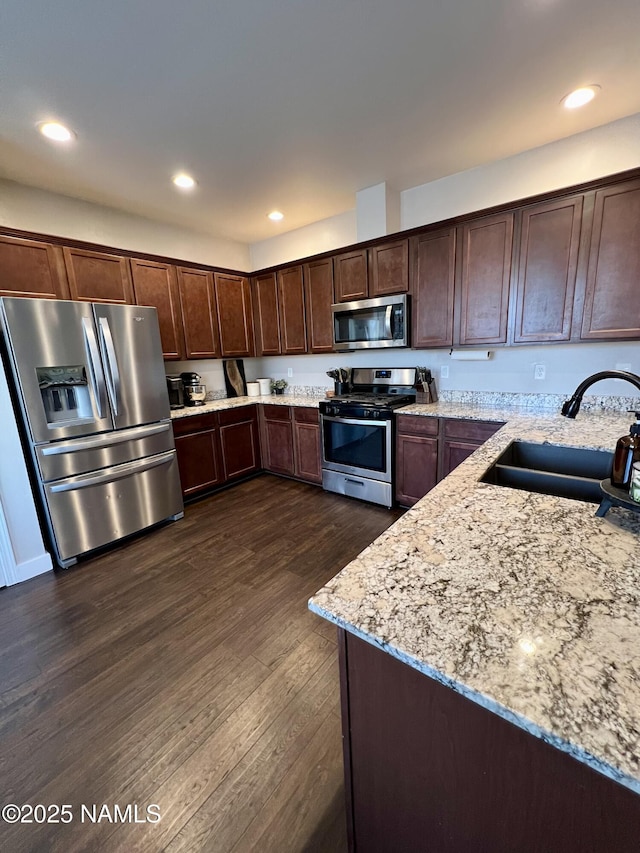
[459,213,513,344]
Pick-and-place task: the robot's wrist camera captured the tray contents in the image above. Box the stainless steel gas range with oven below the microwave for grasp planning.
[320,367,416,507]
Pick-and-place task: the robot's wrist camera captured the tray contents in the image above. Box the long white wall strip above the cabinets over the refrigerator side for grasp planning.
[0,180,250,270]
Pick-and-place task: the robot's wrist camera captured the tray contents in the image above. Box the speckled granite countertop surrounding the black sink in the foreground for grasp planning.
[309,403,640,793]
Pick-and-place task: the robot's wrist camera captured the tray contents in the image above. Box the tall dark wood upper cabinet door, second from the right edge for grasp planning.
[513,196,583,343]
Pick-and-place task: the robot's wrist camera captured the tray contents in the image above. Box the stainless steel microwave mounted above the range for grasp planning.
[331,293,410,350]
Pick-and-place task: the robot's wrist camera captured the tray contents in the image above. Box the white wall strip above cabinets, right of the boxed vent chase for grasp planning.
[401,113,640,230]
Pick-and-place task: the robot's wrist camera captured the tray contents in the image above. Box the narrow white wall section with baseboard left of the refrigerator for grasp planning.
[0,362,52,584]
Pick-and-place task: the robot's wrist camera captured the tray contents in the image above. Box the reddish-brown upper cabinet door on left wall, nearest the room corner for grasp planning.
[214,273,254,356]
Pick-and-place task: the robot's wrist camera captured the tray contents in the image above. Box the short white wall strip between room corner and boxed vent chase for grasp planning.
[250,210,358,270]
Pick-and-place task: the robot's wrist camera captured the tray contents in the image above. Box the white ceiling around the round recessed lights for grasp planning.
[0,0,640,242]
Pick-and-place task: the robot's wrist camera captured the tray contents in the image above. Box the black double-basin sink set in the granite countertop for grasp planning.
[481,441,613,503]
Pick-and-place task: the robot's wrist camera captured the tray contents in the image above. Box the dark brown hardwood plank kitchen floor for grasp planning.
[0,475,401,853]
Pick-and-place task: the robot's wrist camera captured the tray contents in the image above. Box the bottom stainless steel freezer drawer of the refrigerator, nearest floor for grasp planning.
[43,451,183,565]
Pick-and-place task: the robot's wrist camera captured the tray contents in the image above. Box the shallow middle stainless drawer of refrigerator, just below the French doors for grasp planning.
[35,421,175,482]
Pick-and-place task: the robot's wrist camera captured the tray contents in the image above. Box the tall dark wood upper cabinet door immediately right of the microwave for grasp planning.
[411,228,456,349]
